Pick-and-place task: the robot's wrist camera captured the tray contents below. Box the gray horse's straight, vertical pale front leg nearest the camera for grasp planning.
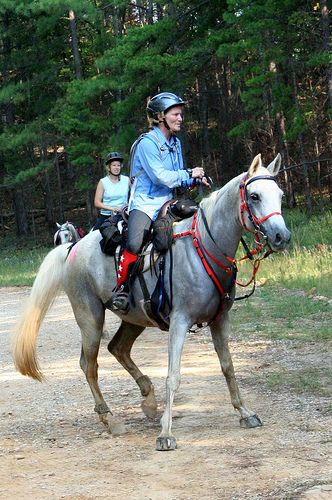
[156,316,189,451]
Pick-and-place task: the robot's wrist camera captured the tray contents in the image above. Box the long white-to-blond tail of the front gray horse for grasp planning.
[12,245,68,382]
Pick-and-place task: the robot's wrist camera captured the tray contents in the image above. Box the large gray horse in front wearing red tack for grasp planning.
[13,155,290,450]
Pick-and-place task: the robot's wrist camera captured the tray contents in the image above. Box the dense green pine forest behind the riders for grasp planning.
[0,0,332,242]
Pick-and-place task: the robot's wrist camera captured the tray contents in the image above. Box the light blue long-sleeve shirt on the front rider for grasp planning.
[129,127,193,220]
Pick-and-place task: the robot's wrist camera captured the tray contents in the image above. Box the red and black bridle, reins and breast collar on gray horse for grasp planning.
[173,175,281,324]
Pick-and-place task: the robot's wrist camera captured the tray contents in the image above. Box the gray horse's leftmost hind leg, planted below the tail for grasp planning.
[73,296,126,436]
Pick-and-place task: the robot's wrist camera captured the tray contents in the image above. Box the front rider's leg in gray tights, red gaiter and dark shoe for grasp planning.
[105,210,152,313]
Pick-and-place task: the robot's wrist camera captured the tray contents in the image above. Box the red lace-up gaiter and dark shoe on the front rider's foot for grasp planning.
[105,248,137,314]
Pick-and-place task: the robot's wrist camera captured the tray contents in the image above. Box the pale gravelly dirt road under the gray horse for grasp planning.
[0,288,332,500]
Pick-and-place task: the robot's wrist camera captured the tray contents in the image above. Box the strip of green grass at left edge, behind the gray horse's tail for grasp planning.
[0,247,50,286]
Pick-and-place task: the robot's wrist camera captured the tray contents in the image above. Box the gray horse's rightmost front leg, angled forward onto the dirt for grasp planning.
[210,312,262,428]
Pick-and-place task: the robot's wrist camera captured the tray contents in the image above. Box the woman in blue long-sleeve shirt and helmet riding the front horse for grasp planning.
[106,92,208,313]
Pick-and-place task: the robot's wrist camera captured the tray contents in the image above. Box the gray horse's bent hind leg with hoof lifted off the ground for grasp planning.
[108,321,157,418]
